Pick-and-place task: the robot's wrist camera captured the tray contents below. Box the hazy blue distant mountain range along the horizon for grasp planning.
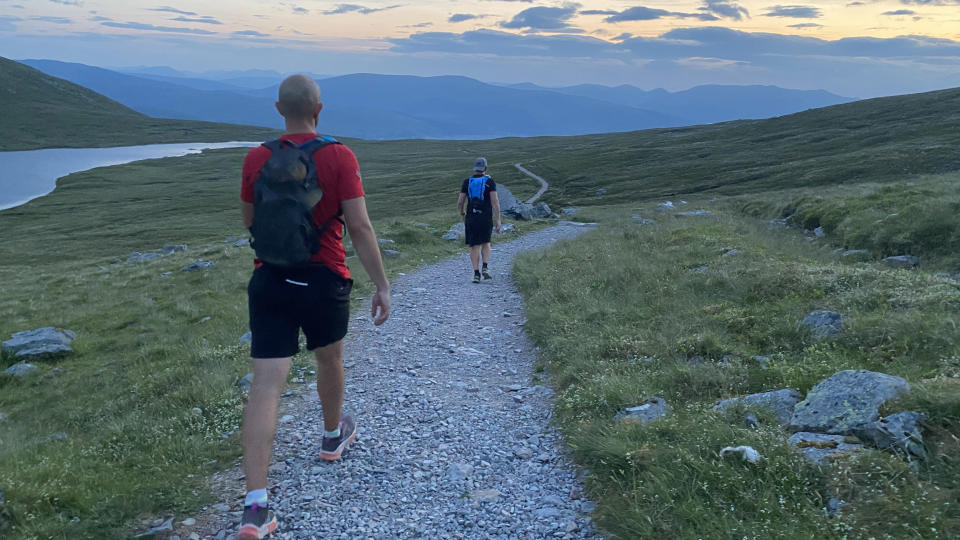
[23,60,852,139]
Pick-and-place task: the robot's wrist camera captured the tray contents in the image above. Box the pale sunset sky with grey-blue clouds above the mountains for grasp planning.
[0,0,960,97]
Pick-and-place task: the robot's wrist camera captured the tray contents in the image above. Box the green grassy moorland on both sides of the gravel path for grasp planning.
[0,84,960,538]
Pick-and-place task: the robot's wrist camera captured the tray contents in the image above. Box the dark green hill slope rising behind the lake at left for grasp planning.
[0,57,275,151]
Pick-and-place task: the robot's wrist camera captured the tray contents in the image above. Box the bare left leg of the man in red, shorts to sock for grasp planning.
[240,358,290,492]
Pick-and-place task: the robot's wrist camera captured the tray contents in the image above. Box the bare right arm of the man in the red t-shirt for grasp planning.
[340,197,390,326]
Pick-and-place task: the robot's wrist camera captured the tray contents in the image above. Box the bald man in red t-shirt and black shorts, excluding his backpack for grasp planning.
[237,75,390,540]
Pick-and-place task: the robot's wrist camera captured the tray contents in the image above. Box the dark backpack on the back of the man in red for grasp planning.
[250,137,340,266]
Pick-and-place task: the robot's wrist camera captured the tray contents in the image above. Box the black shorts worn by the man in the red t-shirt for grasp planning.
[247,265,353,358]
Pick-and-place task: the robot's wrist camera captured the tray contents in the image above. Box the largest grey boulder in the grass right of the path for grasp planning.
[790,370,910,435]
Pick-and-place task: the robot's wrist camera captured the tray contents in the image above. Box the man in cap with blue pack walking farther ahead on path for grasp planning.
[457,157,501,283]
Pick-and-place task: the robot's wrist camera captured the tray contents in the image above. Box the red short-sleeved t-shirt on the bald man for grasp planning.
[240,133,364,278]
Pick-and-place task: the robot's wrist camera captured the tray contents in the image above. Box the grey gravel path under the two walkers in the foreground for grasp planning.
[195,222,598,539]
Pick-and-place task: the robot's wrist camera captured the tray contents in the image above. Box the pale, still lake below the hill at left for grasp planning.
[0,141,260,210]
